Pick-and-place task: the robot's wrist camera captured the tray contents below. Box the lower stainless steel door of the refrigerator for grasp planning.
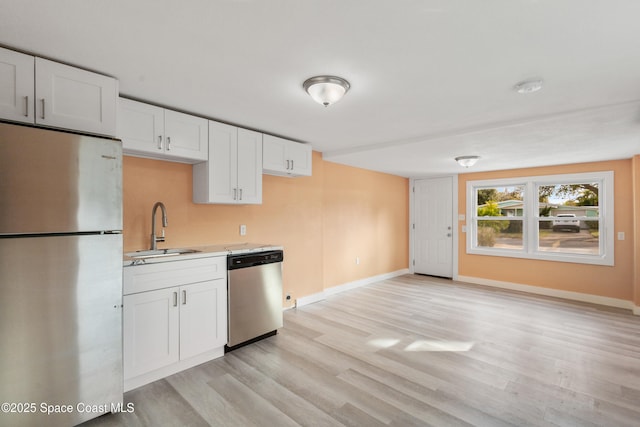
[0,234,123,426]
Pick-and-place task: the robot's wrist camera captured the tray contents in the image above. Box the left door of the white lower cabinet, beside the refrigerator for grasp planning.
[123,288,180,379]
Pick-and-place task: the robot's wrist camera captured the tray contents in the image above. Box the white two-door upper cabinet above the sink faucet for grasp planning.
[117,98,208,163]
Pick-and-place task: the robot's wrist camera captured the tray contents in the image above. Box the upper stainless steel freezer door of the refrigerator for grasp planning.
[0,123,122,234]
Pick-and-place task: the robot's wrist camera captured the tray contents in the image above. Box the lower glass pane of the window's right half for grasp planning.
[538,220,600,255]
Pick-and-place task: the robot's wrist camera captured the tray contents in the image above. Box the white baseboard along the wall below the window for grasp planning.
[458,276,640,315]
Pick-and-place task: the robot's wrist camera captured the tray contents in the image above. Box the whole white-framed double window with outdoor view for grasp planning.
[467,172,614,265]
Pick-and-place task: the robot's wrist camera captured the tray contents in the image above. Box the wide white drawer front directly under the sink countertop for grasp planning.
[123,256,227,295]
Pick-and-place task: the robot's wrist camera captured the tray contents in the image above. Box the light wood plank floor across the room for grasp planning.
[87,275,640,427]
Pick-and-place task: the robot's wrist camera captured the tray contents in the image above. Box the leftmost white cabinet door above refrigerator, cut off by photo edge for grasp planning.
[0,48,35,123]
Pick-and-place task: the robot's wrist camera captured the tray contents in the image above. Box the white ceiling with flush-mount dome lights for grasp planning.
[0,0,640,177]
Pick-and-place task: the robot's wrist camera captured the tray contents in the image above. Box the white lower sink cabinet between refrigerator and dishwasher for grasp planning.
[123,257,227,391]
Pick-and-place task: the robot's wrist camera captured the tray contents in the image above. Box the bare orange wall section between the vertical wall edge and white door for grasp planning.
[324,162,409,287]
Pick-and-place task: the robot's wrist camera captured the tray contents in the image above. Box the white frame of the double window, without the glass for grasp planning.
[466,171,615,266]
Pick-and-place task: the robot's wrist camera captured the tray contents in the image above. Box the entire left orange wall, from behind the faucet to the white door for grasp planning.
[123,152,409,299]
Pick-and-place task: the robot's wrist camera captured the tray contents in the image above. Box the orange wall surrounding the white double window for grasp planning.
[458,160,637,302]
